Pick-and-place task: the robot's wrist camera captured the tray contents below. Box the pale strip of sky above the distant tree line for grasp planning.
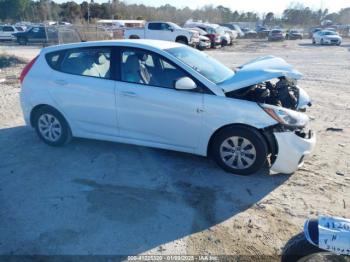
[54,0,350,14]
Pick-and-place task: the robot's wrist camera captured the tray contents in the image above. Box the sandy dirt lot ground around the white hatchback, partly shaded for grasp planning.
[0,40,350,260]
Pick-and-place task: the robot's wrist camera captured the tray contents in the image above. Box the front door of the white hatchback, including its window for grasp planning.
[116,48,203,152]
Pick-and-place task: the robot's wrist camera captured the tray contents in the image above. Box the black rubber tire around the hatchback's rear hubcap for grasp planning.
[33,107,72,147]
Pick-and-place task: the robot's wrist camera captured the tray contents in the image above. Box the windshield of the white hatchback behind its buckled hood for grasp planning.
[165,46,235,84]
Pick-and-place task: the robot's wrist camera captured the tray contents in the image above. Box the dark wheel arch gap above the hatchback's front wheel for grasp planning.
[207,123,278,156]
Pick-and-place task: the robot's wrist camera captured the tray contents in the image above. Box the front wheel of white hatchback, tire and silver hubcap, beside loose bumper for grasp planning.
[211,126,268,175]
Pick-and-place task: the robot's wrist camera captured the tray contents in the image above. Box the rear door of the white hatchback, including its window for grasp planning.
[47,47,118,137]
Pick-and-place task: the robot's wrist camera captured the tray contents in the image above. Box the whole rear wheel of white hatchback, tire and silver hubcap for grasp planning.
[34,107,72,146]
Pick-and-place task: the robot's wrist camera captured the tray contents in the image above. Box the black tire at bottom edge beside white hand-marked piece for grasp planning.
[281,233,328,262]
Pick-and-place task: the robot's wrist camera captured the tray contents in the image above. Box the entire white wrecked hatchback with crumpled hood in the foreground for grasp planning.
[20,40,315,175]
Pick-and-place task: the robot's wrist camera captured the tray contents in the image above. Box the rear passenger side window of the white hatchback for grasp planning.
[58,48,111,79]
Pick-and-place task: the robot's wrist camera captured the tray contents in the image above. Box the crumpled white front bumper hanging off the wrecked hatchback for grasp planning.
[270,131,316,174]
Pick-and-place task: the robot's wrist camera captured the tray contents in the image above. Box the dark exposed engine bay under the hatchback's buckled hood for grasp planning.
[226,77,299,110]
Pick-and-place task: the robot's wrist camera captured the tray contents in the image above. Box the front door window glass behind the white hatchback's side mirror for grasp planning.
[121,49,187,88]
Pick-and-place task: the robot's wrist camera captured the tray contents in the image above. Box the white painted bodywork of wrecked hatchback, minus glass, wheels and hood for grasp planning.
[21,40,315,173]
